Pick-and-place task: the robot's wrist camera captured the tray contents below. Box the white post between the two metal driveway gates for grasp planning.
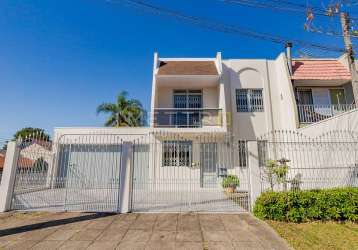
[118,142,133,213]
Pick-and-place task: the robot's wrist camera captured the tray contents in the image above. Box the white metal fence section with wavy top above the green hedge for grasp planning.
[258,131,358,191]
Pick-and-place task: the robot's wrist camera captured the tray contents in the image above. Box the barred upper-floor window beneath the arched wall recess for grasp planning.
[236,89,264,112]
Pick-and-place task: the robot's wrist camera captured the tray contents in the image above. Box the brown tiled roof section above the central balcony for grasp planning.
[158,61,218,75]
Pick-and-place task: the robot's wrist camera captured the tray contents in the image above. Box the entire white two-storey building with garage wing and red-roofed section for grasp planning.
[5,47,358,212]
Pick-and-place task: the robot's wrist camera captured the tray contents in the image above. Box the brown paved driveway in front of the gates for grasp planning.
[0,212,288,250]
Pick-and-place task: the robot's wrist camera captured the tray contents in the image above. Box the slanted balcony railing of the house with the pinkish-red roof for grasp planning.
[297,104,356,124]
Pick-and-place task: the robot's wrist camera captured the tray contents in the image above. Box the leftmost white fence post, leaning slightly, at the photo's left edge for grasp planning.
[0,141,20,213]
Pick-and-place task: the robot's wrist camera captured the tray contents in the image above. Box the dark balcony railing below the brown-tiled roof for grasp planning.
[154,108,222,128]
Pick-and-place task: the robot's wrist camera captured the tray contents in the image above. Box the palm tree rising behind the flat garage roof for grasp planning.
[97,91,146,127]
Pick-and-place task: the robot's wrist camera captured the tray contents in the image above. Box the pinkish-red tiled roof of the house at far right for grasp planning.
[292,59,352,80]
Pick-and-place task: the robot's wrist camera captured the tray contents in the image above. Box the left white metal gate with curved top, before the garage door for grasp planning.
[11,134,122,212]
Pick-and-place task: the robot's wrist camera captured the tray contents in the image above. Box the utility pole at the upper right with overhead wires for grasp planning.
[340,12,358,104]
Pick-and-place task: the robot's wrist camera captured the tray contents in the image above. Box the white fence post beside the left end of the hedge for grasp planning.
[247,141,261,210]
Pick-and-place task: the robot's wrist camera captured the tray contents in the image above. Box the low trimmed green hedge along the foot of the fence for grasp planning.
[254,188,358,222]
